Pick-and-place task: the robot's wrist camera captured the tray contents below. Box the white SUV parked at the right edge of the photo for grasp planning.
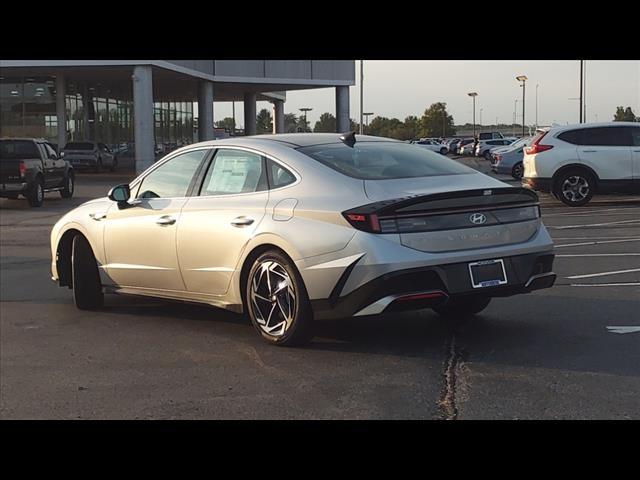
[522,122,640,207]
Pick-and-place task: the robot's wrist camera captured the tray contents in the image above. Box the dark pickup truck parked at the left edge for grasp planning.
[0,138,75,207]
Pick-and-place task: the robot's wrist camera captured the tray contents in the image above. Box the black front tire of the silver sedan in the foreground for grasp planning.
[71,235,104,310]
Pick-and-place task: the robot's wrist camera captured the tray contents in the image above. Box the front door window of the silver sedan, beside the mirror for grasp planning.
[137,150,208,198]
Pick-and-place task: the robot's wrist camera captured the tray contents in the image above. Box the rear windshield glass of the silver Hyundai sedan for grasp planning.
[298,142,475,180]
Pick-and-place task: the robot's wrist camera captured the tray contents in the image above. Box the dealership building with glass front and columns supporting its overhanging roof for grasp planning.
[0,60,355,172]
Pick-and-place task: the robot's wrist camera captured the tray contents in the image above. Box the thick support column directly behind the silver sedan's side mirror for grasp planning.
[132,65,155,173]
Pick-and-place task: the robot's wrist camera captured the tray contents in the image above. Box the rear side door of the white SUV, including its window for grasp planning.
[578,126,633,182]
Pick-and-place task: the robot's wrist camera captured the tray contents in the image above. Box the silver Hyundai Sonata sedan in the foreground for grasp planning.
[51,132,555,345]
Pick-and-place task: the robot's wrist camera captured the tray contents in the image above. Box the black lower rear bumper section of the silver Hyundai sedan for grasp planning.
[311,251,556,320]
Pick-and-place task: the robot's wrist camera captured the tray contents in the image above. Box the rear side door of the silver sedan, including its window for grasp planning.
[178,148,269,295]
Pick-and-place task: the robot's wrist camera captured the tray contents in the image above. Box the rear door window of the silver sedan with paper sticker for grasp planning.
[200,148,267,196]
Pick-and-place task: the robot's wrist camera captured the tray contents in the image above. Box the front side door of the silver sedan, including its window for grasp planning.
[104,149,209,291]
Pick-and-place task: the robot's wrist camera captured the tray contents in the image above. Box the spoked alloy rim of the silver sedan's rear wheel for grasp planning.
[250,260,296,337]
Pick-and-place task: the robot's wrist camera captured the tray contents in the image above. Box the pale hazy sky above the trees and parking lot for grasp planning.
[214,60,640,128]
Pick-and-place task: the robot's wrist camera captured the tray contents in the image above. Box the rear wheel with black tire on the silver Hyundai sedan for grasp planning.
[244,250,313,347]
